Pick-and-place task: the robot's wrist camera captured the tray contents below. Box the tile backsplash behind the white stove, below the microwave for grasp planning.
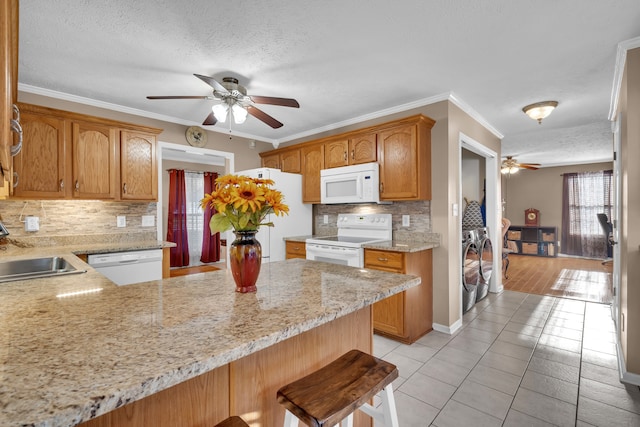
[313,200,439,242]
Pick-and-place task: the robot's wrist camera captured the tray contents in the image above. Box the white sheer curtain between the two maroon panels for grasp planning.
[184,171,204,266]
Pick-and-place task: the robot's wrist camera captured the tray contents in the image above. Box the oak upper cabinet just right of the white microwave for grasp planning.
[378,116,435,201]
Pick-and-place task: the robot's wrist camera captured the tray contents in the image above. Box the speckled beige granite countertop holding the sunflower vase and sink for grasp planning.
[0,254,420,426]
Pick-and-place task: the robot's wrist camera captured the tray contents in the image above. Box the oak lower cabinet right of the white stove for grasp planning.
[364,249,433,344]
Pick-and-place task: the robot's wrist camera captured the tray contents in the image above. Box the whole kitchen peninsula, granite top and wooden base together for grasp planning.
[0,253,420,427]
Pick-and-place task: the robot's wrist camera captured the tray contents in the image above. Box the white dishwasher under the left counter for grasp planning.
[87,249,162,285]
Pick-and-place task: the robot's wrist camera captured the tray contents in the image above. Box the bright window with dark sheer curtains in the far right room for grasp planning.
[562,170,613,258]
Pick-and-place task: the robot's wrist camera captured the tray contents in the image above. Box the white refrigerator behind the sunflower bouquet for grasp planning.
[236,168,313,263]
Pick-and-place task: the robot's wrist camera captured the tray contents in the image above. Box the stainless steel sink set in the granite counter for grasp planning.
[0,257,86,283]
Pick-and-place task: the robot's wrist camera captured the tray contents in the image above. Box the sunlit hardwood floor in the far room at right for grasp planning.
[503,254,613,304]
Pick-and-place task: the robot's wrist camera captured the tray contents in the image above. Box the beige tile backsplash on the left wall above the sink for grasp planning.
[0,200,157,244]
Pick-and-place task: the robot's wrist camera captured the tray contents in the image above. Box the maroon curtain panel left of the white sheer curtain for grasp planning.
[167,169,189,267]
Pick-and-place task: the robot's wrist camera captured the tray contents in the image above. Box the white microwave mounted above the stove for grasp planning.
[320,163,380,204]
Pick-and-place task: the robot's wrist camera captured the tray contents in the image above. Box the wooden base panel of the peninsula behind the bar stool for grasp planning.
[80,306,373,427]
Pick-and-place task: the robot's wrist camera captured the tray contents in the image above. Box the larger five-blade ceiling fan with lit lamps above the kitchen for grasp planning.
[147,74,300,129]
